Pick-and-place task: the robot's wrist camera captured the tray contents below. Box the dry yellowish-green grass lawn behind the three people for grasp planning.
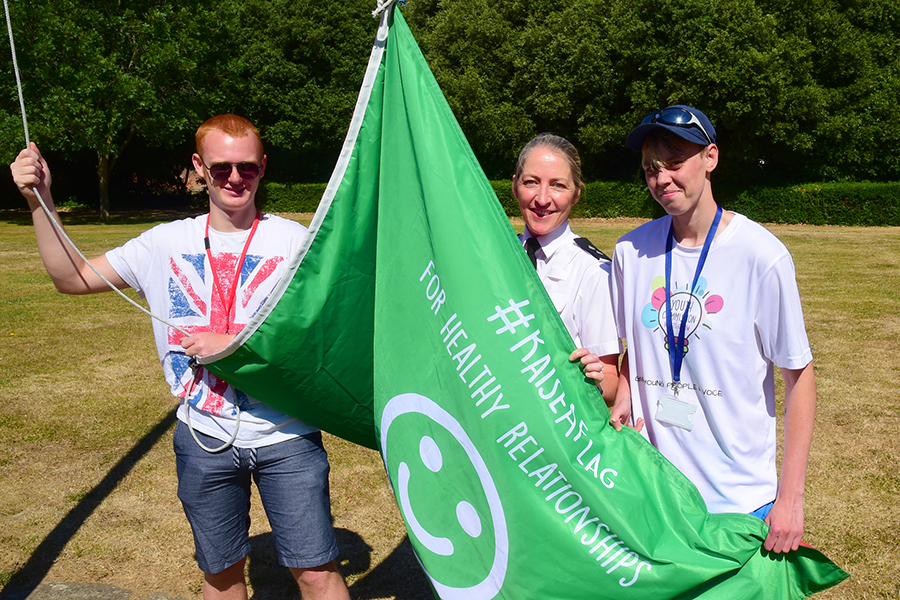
[0,211,900,600]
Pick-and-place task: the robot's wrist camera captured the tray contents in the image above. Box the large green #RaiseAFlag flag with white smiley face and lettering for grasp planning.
[202,3,847,600]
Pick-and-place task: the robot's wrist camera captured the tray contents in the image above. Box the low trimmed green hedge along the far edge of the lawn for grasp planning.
[259,181,900,226]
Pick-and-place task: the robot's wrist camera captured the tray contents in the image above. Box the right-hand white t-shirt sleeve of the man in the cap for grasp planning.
[755,253,812,369]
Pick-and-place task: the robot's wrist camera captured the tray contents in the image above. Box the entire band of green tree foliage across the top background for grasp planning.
[0,0,900,216]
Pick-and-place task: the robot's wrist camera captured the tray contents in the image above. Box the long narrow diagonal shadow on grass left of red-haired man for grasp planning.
[0,407,177,600]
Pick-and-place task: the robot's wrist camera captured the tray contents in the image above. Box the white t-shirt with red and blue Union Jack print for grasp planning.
[106,214,316,448]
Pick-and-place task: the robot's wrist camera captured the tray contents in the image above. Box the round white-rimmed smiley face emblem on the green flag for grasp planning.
[381,394,509,600]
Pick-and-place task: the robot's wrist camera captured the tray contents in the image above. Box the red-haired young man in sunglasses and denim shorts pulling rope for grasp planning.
[10,115,349,600]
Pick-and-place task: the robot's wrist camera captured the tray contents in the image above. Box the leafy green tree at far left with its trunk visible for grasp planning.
[0,0,221,220]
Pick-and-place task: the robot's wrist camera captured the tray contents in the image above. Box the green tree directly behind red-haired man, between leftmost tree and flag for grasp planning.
[217,0,378,181]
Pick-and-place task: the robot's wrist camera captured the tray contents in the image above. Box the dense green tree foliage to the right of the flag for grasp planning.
[407,0,900,180]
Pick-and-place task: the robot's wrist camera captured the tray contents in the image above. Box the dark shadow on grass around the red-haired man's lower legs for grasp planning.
[248,528,434,600]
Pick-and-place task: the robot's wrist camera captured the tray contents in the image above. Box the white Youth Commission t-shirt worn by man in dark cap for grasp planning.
[612,214,812,513]
